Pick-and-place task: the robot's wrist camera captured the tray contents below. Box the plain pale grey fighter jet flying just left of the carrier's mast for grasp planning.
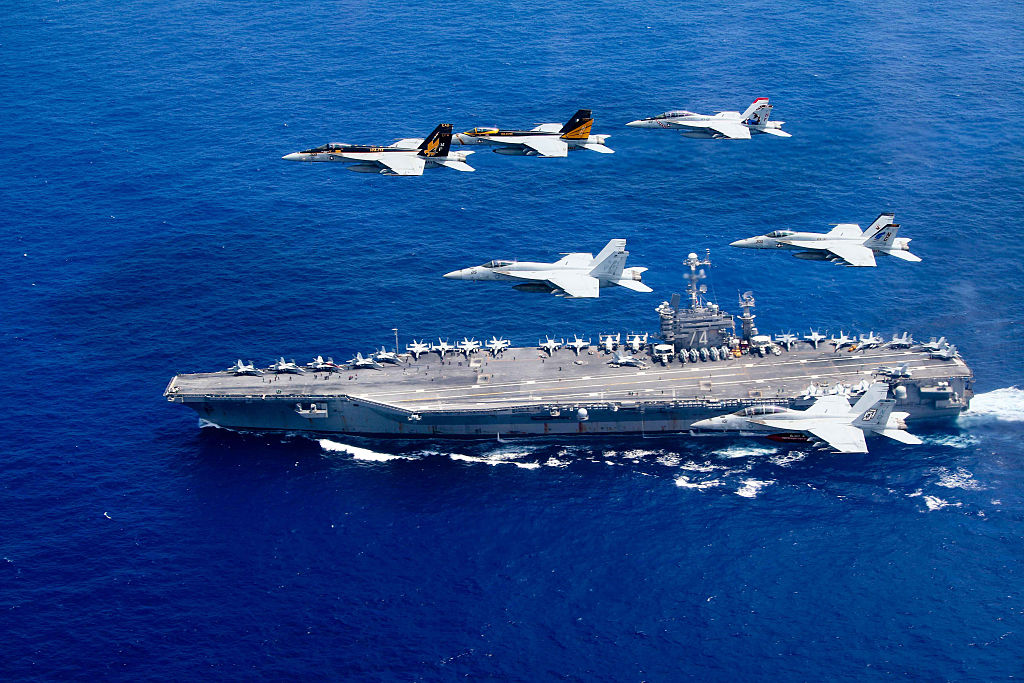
[444,240,651,299]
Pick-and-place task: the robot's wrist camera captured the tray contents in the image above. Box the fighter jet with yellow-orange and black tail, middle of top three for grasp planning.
[453,110,614,157]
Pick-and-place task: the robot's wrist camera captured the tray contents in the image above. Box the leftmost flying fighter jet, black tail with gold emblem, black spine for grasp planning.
[282,123,476,175]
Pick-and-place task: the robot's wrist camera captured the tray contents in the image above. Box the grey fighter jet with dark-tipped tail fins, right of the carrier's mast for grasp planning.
[732,213,921,267]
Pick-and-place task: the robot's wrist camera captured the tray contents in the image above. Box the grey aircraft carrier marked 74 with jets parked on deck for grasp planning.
[164,254,974,438]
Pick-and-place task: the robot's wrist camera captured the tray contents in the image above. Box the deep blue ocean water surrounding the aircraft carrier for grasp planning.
[0,0,1024,681]
